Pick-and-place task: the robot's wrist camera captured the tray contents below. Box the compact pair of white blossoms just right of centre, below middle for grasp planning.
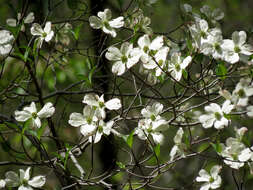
[135,102,168,144]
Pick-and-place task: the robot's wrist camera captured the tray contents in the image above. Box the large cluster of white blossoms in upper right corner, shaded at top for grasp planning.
[185,5,253,64]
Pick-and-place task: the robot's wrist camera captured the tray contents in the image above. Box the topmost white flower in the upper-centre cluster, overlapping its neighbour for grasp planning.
[138,34,163,69]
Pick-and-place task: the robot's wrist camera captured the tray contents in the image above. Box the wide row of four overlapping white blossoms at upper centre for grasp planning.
[106,34,192,81]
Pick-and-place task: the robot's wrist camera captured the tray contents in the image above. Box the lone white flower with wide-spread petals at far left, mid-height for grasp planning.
[14,102,55,128]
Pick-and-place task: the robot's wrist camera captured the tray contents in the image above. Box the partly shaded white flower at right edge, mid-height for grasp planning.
[231,78,253,106]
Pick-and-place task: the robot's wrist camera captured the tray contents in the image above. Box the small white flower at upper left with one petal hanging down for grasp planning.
[31,22,54,48]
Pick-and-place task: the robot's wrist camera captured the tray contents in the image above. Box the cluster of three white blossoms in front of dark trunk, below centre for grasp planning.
[68,94,121,143]
